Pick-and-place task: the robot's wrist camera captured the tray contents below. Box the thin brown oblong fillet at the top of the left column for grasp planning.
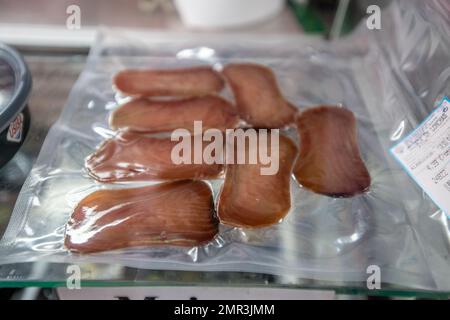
[113,67,224,97]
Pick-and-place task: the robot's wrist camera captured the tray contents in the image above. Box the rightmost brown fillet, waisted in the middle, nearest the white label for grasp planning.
[294,106,370,197]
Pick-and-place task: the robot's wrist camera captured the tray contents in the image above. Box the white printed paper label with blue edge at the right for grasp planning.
[391,97,450,215]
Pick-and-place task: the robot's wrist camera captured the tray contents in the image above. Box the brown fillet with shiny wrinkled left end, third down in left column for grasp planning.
[85,131,223,182]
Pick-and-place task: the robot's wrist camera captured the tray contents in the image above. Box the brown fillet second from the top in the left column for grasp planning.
[109,95,239,133]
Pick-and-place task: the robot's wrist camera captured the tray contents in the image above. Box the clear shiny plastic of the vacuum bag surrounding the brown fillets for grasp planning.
[0,1,450,291]
